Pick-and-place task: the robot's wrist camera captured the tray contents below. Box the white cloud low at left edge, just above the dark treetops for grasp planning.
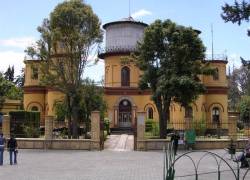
[0,51,25,76]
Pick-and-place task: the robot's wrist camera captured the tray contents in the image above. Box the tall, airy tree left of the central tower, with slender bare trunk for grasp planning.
[26,0,102,138]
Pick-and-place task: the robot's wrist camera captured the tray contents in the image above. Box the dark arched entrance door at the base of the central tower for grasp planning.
[119,100,132,128]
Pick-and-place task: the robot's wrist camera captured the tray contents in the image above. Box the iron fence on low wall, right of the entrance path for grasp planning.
[145,120,250,139]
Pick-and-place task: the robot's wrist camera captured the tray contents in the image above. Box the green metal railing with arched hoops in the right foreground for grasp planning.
[163,143,250,180]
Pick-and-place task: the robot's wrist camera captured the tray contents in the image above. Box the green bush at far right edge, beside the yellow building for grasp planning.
[238,96,250,123]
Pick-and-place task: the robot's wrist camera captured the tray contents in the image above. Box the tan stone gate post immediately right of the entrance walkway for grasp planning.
[136,111,146,150]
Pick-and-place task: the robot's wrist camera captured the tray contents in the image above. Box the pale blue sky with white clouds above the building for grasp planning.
[0,0,250,81]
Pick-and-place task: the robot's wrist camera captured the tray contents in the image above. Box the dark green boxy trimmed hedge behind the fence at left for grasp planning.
[9,111,40,138]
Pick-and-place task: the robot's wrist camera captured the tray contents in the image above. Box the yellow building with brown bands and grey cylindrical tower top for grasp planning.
[24,18,228,133]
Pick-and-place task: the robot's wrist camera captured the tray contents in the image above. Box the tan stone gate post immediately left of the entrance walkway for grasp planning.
[91,111,101,150]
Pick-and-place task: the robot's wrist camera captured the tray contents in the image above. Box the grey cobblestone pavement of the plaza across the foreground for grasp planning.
[0,143,250,180]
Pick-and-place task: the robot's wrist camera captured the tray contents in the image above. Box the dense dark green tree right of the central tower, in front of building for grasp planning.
[135,20,211,138]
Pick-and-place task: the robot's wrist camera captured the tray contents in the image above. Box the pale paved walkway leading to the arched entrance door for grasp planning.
[104,134,134,151]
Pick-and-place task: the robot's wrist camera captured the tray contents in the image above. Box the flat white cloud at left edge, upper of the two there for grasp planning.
[0,37,36,49]
